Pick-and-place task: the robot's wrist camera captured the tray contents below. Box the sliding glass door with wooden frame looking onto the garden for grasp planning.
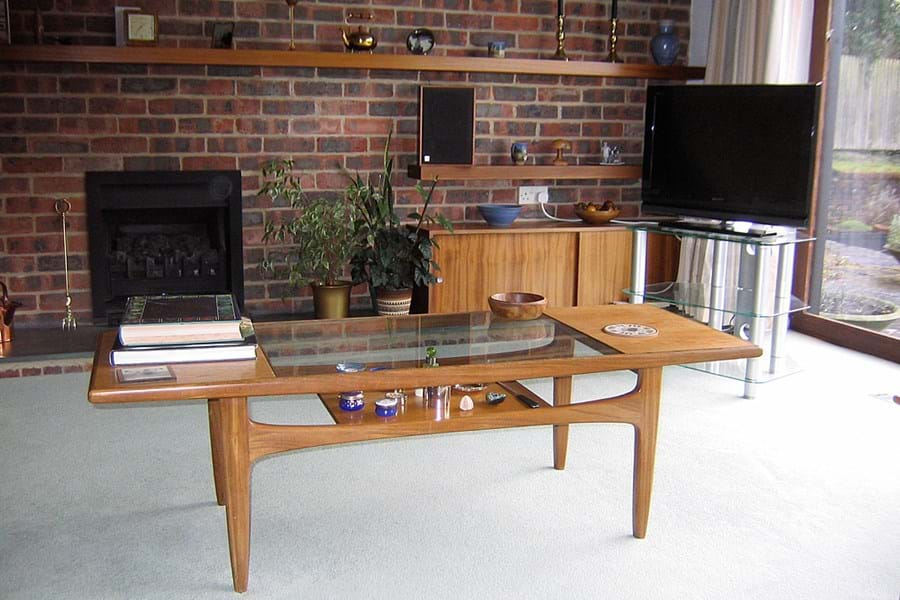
[796,0,900,360]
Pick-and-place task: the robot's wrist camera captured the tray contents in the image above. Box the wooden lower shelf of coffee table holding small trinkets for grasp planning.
[319,381,550,425]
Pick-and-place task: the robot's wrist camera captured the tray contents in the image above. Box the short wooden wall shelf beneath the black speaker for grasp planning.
[407,165,641,180]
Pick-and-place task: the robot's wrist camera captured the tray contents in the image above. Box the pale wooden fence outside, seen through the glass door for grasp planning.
[834,56,900,150]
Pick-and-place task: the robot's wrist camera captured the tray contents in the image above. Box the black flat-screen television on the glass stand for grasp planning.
[641,85,819,226]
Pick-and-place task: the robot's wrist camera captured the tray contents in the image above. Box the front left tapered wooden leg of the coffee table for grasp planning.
[219,398,250,592]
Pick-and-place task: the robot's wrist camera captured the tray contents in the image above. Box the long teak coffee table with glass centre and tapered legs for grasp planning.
[88,304,761,592]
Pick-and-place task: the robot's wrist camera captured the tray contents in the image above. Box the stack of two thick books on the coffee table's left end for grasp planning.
[109,294,257,366]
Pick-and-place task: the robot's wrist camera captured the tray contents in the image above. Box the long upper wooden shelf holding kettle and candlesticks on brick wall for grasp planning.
[0,46,706,80]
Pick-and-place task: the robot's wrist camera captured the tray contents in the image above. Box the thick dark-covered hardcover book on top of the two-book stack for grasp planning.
[119,294,243,346]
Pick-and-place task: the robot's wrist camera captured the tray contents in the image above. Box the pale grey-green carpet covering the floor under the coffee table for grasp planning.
[0,333,900,600]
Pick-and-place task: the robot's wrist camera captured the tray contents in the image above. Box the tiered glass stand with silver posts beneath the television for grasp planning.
[625,223,815,398]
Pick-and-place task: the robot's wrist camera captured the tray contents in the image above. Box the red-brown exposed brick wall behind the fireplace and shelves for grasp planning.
[0,0,690,323]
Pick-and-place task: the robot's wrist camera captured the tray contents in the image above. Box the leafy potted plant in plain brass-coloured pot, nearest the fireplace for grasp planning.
[259,159,360,319]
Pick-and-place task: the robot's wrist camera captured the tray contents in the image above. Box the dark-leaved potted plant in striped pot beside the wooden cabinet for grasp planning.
[346,133,453,315]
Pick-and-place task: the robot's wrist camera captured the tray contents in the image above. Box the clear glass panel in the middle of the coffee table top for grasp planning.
[255,312,618,376]
